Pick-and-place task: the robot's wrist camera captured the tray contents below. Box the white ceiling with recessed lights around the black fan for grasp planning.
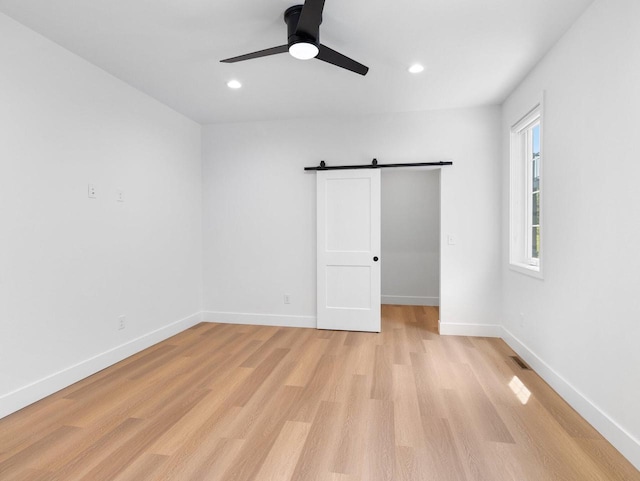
[0,0,592,123]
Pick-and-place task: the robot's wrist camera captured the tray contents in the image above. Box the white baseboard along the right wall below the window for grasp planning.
[501,327,640,470]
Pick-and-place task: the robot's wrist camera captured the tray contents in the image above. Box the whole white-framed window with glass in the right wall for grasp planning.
[509,103,543,277]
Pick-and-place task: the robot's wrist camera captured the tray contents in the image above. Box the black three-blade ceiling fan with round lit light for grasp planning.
[220,0,369,75]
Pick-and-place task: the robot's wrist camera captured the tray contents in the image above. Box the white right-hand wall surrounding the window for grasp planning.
[502,0,640,468]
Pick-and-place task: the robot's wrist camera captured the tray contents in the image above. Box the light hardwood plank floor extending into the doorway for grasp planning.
[0,306,640,481]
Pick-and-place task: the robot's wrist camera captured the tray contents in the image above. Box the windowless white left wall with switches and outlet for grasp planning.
[0,15,202,416]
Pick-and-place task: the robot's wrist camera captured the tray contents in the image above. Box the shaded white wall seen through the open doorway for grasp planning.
[380,168,440,306]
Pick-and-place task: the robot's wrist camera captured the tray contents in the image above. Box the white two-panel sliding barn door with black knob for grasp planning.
[317,169,380,332]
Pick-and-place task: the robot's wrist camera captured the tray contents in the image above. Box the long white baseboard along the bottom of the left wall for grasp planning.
[0,312,202,418]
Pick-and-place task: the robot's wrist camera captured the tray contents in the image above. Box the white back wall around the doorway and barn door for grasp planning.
[203,107,501,334]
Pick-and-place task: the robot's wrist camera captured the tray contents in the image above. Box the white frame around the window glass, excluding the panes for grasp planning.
[509,98,544,279]
